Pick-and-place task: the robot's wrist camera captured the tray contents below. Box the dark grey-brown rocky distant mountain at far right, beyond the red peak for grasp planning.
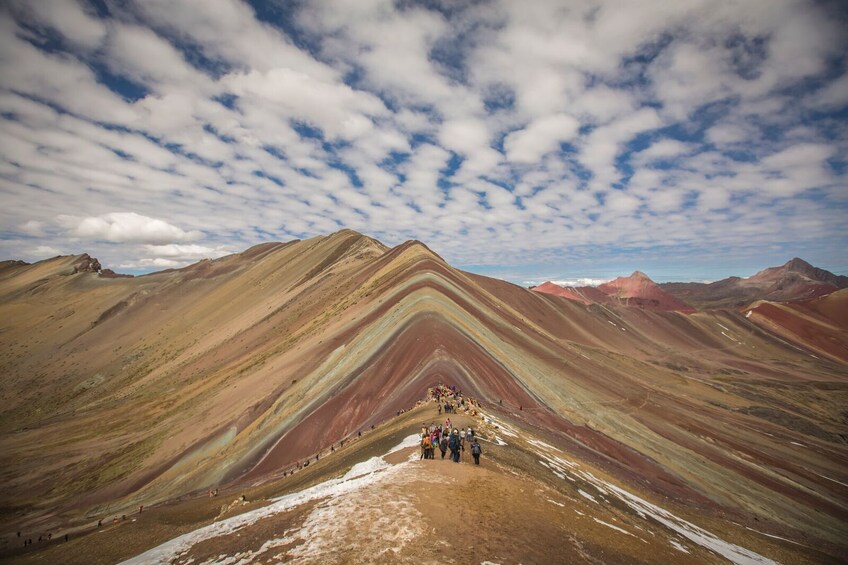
[660,257,848,310]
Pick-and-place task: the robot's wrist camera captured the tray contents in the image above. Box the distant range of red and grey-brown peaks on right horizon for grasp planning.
[533,257,848,313]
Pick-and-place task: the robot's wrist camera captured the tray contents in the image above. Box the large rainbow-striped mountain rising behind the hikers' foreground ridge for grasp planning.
[0,230,848,560]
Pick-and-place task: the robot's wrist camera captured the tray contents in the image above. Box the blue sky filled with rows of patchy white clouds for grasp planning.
[0,0,848,284]
